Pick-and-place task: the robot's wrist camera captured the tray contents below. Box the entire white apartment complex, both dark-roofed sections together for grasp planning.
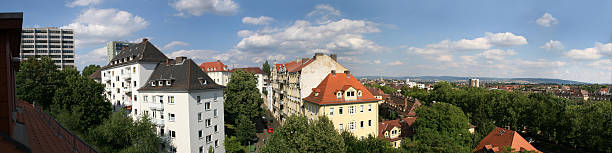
[101,39,225,153]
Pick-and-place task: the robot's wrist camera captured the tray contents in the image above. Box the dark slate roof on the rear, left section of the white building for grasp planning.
[102,39,168,69]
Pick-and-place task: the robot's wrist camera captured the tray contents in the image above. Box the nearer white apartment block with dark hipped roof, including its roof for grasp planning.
[137,57,225,152]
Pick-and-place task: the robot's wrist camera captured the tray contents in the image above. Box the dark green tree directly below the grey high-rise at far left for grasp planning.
[16,56,64,109]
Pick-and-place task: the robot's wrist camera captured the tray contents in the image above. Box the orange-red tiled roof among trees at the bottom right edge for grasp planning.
[474,127,541,152]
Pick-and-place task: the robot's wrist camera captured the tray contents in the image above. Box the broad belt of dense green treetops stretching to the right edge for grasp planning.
[405,82,612,152]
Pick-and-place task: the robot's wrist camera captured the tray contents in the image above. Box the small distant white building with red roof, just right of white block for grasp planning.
[200,60,231,86]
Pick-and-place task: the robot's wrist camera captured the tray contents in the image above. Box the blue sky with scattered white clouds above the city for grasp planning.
[0,0,612,83]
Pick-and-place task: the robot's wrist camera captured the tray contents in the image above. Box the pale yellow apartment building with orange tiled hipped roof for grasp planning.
[304,70,380,139]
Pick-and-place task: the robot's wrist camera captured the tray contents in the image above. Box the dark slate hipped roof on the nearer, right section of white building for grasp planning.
[138,58,224,91]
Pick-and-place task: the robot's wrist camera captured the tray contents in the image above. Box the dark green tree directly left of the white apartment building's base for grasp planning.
[51,73,112,133]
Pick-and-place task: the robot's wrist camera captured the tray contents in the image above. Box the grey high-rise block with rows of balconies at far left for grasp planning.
[20,27,75,70]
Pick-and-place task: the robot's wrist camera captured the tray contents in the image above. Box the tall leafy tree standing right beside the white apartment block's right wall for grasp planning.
[224,70,264,134]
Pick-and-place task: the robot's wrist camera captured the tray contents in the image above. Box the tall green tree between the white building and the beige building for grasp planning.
[224,70,264,144]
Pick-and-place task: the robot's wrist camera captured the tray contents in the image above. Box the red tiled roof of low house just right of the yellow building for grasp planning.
[378,117,417,141]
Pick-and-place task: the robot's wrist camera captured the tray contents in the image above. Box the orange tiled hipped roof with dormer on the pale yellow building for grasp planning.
[304,73,380,105]
